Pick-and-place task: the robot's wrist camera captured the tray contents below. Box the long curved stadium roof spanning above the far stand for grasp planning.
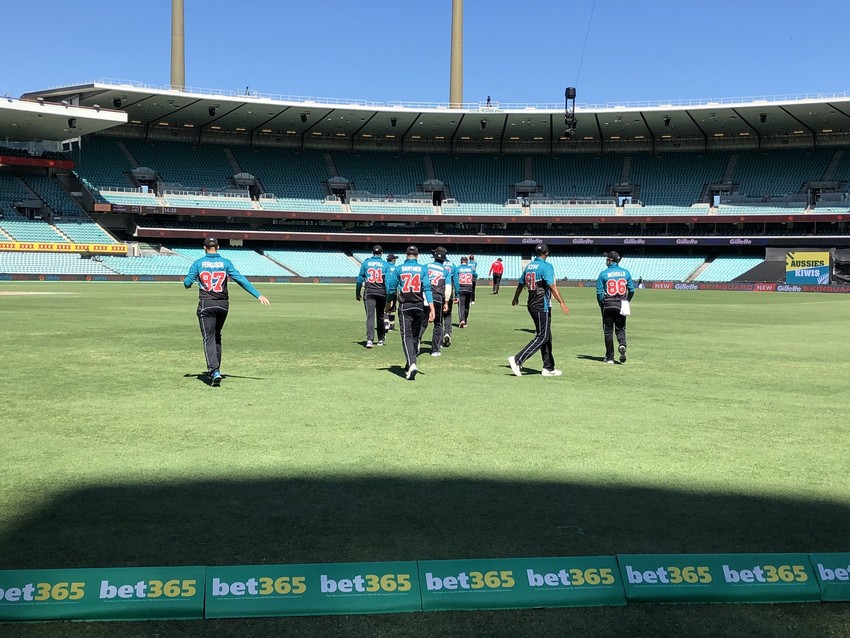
[16,80,850,143]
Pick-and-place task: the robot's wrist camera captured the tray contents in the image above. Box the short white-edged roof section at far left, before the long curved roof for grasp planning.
[0,97,127,142]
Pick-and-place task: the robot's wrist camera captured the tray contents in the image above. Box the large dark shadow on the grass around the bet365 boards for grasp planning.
[0,480,850,637]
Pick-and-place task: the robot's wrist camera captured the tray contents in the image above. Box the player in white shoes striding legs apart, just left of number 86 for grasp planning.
[508,244,570,377]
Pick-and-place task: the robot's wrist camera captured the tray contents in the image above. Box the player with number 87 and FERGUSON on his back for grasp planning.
[183,237,269,387]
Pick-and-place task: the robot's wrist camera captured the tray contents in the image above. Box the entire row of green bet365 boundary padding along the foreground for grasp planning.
[0,553,850,622]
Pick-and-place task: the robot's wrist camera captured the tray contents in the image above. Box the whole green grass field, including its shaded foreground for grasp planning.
[0,283,850,636]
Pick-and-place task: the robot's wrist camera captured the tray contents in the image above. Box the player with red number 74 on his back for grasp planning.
[387,246,434,381]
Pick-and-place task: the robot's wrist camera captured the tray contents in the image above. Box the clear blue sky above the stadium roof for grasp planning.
[6,0,850,104]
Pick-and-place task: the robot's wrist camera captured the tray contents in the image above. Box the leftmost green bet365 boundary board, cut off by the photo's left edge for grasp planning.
[0,567,206,620]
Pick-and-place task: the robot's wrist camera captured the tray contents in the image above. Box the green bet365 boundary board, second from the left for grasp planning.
[206,562,422,618]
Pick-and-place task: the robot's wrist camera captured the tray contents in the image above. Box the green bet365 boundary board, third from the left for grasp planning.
[419,556,626,611]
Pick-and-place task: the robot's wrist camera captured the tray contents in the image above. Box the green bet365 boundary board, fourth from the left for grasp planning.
[618,554,820,603]
